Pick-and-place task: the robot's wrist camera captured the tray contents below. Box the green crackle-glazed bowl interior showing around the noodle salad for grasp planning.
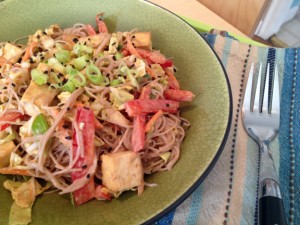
[0,0,231,225]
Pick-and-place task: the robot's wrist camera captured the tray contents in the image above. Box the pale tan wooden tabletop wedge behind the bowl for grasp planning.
[149,0,246,37]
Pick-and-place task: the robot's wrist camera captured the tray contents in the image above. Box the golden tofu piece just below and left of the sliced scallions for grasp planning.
[21,81,58,116]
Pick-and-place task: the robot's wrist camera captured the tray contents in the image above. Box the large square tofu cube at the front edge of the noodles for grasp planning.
[101,151,144,194]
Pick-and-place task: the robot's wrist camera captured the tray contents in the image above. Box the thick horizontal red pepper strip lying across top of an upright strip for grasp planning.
[125,99,179,117]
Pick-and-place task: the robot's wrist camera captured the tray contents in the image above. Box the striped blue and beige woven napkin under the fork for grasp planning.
[156,34,300,225]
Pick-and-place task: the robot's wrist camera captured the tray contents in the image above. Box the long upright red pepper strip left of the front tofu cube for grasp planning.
[71,108,96,205]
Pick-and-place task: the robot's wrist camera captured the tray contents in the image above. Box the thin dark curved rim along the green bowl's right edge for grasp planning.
[142,0,233,225]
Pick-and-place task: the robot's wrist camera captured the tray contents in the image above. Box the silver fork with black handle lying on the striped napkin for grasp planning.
[242,63,286,225]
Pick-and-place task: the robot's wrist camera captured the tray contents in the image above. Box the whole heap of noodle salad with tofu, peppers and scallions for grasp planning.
[0,14,194,222]
